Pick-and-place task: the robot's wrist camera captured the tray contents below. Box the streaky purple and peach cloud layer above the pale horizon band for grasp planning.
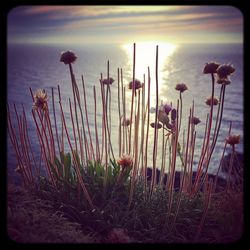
[8,5,243,44]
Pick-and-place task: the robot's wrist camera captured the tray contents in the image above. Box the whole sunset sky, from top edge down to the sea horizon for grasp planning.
[7,5,243,44]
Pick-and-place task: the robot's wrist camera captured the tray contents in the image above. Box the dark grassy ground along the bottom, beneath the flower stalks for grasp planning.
[8,176,243,243]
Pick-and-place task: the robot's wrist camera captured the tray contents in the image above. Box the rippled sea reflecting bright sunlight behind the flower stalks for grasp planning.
[7,44,244,182]
